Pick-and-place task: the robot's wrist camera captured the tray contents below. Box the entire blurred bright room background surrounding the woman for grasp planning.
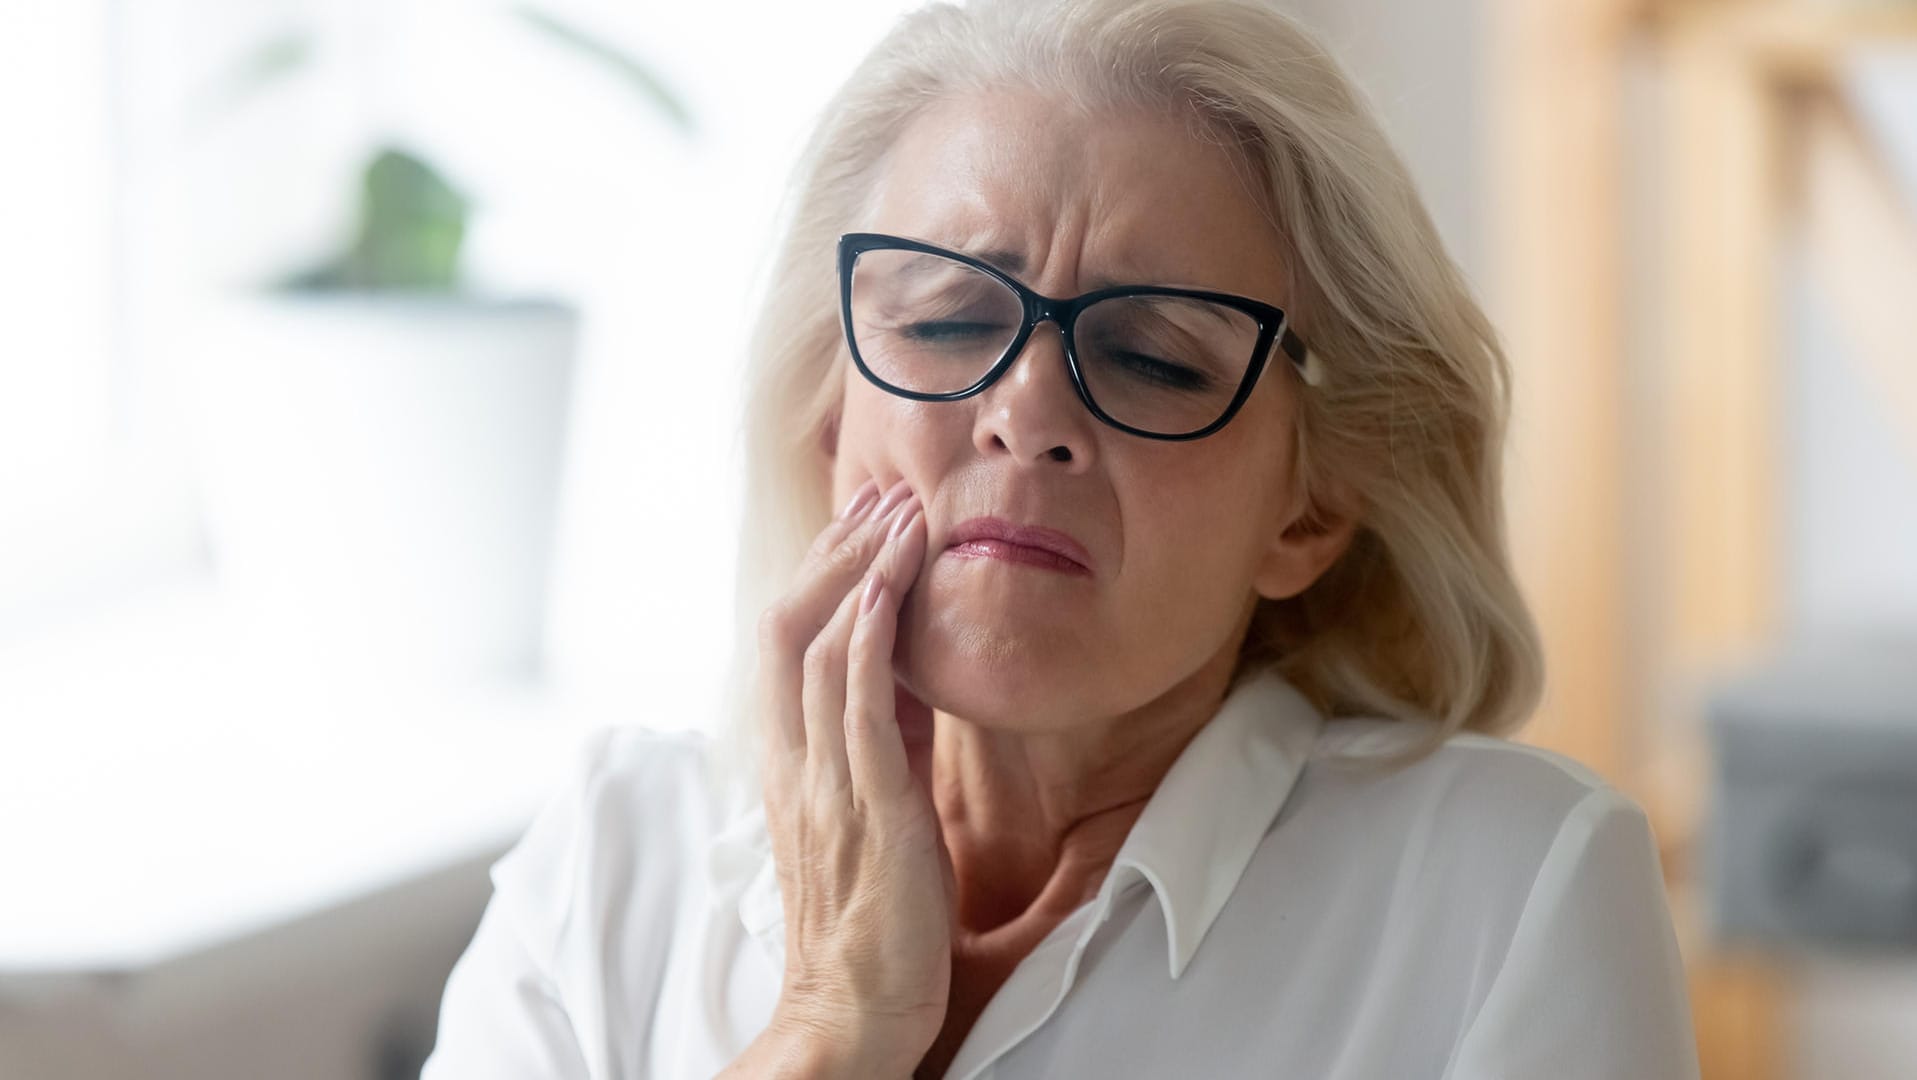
[0,0,1917,1080]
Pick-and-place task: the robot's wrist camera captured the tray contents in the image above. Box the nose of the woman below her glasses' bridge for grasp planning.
[972,318,1098,472]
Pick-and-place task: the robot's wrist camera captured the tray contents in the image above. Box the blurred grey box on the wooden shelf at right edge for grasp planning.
[1704,629,1917,953]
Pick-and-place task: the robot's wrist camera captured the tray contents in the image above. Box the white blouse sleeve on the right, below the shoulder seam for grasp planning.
[1445,788,1698,1080]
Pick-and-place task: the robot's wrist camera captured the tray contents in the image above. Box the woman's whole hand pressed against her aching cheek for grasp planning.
[755,481,957,1074]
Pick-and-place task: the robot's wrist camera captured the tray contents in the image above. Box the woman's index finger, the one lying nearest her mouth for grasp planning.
[843,508,926,810]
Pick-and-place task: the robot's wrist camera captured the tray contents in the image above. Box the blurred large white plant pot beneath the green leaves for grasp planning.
[182,293,579,681]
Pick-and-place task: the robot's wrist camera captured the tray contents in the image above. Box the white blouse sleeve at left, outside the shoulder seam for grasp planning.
[420,729,612,1080]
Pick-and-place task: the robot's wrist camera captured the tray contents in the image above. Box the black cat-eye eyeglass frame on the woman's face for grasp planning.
[838,232,1317,443]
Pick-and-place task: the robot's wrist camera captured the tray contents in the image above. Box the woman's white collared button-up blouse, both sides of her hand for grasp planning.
[422,673,1698,1080]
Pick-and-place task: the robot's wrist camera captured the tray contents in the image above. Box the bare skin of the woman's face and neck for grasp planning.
[832,82,1351,1061]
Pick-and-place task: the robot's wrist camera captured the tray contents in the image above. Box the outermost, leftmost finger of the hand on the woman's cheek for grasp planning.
[759,481,911,763]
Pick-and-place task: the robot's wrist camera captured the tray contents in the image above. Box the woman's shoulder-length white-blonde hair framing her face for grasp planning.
[705,0,1543,794]
